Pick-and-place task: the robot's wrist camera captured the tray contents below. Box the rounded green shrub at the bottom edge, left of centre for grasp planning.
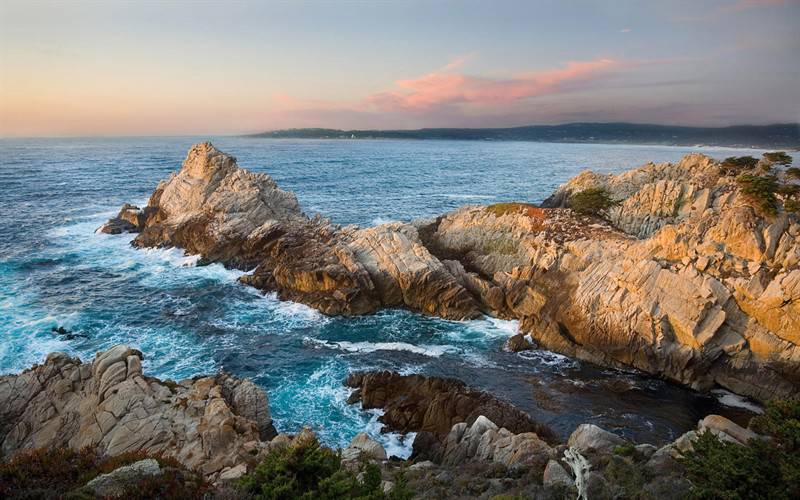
[239,437,384,500]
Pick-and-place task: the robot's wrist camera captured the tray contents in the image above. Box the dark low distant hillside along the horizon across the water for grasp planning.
[249,123,800,149]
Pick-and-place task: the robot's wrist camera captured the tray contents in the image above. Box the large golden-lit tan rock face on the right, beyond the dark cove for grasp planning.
[428,155,800,399]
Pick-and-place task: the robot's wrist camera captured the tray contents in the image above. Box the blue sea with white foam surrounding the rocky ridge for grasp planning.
[0,138,754,453]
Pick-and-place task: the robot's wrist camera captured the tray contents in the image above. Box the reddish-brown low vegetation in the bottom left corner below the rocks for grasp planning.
[0,448,208,500]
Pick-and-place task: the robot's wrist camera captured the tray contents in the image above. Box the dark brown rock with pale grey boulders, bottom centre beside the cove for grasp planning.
[345,371,556,466]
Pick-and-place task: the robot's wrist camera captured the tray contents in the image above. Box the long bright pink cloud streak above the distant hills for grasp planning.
[365,59,621,111]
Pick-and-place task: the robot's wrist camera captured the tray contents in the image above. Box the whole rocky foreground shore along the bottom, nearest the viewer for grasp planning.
[0,345,797,499]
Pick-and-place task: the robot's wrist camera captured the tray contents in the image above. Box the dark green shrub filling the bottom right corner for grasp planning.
[680,401,800,499]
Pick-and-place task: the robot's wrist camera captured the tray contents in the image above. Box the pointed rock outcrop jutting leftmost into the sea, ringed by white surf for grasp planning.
[104,143,479,319]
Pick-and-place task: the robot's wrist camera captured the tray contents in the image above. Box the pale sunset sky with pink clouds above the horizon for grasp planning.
[0,0,800,137]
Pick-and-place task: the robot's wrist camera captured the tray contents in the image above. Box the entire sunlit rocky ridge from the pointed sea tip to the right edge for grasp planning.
[101,143,800,400]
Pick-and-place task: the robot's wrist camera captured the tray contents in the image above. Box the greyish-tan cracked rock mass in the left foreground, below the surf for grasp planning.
[0,345,275,480]
